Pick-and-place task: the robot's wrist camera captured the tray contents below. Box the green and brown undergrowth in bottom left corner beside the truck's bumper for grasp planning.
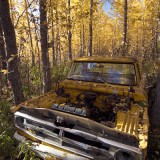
[0,100,39,160]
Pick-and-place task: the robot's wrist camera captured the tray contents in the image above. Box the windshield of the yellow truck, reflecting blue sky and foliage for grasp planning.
[67,62,136,86]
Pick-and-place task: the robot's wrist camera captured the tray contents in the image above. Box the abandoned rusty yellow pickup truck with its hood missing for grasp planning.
[13,57,149,160]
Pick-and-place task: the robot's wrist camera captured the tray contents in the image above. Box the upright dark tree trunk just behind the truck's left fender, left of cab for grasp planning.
[40,0,51,93]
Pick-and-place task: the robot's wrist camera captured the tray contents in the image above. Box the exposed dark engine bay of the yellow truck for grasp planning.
[51,88,133,128]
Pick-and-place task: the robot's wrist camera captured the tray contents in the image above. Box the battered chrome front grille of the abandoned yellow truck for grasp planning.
[15,109,139,160]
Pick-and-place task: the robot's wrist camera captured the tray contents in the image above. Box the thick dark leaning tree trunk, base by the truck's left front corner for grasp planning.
[0,0,24,104]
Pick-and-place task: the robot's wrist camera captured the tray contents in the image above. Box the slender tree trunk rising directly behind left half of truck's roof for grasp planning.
[88,0,93,56]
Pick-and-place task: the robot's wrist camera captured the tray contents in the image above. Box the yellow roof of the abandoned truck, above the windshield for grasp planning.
[74,57,138,63]
